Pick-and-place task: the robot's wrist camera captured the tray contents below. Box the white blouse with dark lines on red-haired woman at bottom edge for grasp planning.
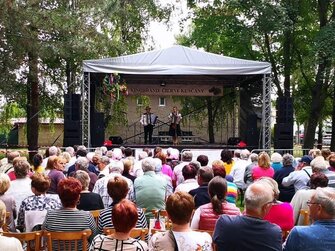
[89,234,148,251]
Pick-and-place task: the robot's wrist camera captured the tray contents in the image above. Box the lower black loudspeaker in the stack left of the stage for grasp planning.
[63,119,81,146]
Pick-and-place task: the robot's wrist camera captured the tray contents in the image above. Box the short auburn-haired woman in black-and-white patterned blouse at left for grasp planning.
[17,173,61,231]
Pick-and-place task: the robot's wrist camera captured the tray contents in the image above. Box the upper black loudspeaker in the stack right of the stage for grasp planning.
[276,97,293,124]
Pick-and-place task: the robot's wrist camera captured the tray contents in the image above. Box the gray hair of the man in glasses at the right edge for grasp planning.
[314,187,335,218]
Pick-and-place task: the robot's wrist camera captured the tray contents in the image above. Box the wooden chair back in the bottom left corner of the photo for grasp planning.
[3,231,42,251]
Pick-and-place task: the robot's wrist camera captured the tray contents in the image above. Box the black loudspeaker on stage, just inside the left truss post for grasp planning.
[91,112,105,147]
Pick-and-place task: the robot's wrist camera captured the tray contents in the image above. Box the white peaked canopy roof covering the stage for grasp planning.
[83,45,271,75]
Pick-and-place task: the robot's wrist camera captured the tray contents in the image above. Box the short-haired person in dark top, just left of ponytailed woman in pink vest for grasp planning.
[189,166,214,208]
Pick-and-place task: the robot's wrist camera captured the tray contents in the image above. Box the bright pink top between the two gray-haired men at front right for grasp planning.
[264,202,294,231]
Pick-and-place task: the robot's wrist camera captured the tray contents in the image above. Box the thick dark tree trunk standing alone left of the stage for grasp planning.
[27,51,39,159]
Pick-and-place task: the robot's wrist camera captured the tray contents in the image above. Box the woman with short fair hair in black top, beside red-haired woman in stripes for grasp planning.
[74,170,104,211]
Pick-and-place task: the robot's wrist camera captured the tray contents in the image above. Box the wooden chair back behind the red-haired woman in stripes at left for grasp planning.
[43,229,92,251]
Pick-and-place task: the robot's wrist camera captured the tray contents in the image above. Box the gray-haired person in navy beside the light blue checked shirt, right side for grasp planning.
[273,153,295,202]
